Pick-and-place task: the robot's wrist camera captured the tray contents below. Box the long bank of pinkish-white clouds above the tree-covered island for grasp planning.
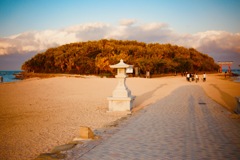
[0,19,240,59]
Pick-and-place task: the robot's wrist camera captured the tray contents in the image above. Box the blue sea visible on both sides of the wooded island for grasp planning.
[0,69,240,83]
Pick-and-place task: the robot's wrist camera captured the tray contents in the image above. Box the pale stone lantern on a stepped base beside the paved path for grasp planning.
[107,59,134,111]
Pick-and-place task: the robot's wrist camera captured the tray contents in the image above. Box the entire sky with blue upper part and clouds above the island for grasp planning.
[0,0,240,70]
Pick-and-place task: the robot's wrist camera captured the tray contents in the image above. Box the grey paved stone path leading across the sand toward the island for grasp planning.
[64,85,240,160]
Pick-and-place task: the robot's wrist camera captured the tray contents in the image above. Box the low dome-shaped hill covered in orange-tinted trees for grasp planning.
[22,39,218,74]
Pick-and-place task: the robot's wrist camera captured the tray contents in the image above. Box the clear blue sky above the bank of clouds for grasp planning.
[0,0,240,37]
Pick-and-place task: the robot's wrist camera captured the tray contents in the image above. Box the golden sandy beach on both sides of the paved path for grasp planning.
[0,74,240,160]
